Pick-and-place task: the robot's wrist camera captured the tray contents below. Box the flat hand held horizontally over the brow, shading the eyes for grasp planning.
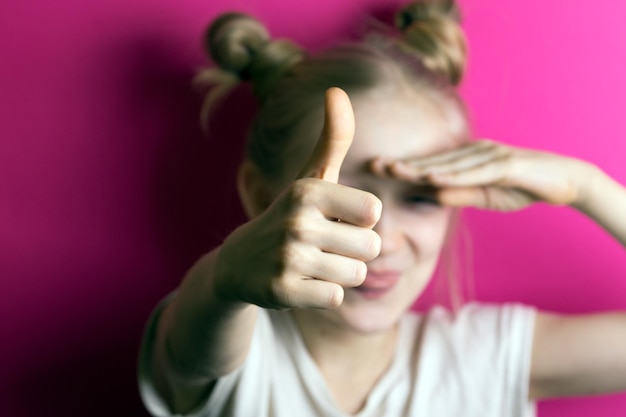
[372,140,591,211]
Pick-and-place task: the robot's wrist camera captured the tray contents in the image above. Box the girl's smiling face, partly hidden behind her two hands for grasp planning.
[298,89,467,332]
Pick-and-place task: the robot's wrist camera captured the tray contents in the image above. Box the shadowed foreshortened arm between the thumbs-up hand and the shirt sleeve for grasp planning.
[153,245,256,411]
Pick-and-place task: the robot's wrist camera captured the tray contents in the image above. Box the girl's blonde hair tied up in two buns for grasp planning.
[195,0,467,304]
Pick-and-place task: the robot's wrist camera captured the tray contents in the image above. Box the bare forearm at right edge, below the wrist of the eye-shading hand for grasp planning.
[573,165,626,246]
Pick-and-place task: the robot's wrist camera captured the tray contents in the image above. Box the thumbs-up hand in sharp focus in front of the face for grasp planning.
[214,88,382,309]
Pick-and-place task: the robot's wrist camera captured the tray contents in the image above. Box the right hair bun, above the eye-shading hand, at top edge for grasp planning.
[395,0,467,85]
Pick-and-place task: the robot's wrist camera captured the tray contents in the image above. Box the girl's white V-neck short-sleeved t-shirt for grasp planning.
[139,303,535,417]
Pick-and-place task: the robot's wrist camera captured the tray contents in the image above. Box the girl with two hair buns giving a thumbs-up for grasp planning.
[139,1,626,417]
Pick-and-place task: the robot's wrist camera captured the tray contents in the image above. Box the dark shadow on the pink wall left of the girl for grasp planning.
[5,31,254,417]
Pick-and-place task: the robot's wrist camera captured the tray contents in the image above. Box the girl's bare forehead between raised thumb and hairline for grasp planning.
[344,91,467,171]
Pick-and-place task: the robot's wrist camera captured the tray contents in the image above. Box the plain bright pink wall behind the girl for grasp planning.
[0,0,626,417]
